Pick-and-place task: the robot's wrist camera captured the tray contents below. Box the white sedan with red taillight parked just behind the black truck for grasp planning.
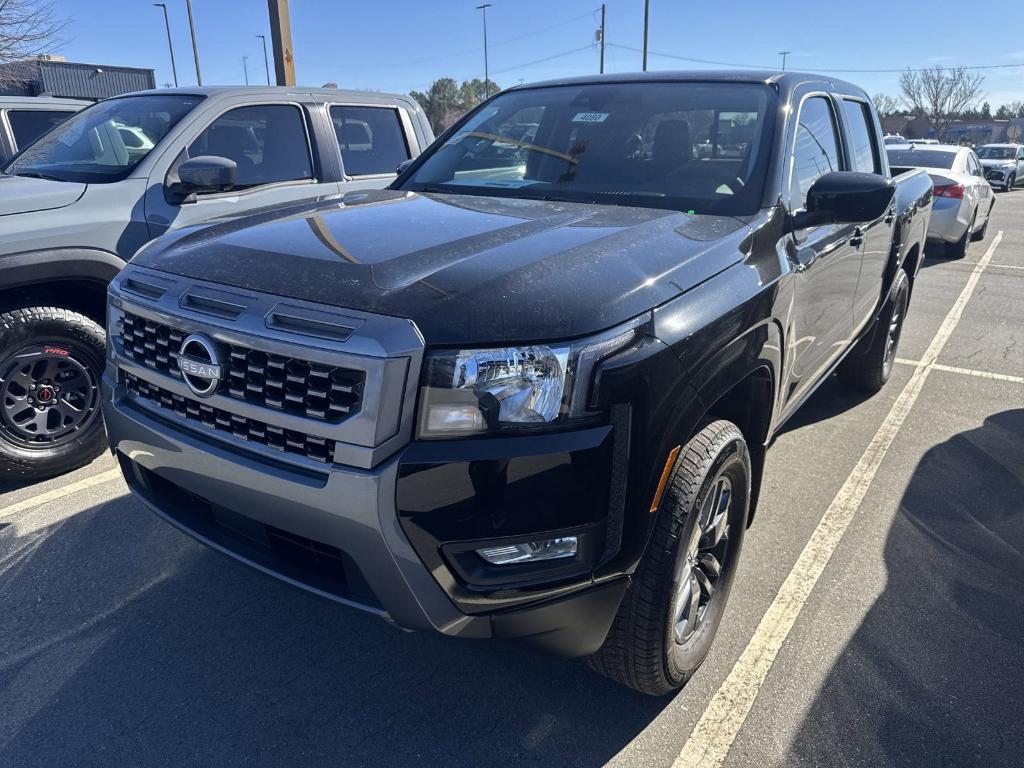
[886,144,995,258]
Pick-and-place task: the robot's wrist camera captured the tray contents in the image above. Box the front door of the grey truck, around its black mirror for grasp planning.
[145,99,338,238]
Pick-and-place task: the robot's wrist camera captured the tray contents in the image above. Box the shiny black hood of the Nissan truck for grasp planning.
[134,190,750,344]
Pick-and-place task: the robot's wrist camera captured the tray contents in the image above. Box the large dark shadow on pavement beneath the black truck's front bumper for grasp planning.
[0,497,672,768]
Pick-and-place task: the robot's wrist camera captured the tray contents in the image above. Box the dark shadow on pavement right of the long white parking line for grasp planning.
[784,410,1024,766]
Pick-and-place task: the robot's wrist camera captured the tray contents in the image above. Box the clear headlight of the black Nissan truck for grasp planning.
[418,322,639,439]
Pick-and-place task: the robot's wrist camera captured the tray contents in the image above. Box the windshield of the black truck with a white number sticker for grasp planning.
[398,82,774,215]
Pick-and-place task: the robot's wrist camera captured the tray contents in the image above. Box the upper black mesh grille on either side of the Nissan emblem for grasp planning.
[122,312,366,424]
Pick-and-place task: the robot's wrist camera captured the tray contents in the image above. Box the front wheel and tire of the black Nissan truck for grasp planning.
[590,421,751,695]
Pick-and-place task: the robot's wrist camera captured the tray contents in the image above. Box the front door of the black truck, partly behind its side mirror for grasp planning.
[786,93,863,401]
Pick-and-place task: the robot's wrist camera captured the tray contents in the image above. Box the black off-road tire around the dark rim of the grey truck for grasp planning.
[0,306,106,481]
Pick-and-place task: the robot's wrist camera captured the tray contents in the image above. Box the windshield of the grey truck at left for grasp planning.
[5,94,203,184]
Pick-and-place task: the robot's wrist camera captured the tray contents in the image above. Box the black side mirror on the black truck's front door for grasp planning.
[793,171,896,229]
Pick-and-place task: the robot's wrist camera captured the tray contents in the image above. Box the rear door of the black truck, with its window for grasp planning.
[840,96,896,335]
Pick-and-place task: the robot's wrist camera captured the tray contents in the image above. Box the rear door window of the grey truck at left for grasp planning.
[331,105,410,176]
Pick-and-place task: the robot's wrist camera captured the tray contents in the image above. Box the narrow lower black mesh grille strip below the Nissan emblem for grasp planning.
[124,373,335,464]
